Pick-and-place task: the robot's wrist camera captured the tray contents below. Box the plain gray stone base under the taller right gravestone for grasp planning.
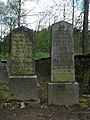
[48,82,79,105]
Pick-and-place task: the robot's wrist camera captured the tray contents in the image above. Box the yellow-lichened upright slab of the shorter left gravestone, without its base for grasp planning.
[10,26,35,76]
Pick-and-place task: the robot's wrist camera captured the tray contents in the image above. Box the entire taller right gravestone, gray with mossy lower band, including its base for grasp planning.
[48,21,79,105]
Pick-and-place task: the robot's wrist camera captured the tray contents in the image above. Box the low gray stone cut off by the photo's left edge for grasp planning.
[0,60,8,83]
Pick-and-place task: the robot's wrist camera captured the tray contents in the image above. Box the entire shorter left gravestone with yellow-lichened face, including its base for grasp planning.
[9,26,37,100]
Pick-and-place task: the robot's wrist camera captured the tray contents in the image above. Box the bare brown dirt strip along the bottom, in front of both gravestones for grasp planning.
[0,105,90,120]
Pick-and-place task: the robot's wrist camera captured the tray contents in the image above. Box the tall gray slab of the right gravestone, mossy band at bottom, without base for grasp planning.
[51,21,75,82]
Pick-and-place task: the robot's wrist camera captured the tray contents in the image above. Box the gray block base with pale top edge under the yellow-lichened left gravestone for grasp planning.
[9,75,37,101]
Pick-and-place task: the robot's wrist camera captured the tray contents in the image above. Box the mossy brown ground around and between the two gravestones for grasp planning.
[0,57,90,120]
